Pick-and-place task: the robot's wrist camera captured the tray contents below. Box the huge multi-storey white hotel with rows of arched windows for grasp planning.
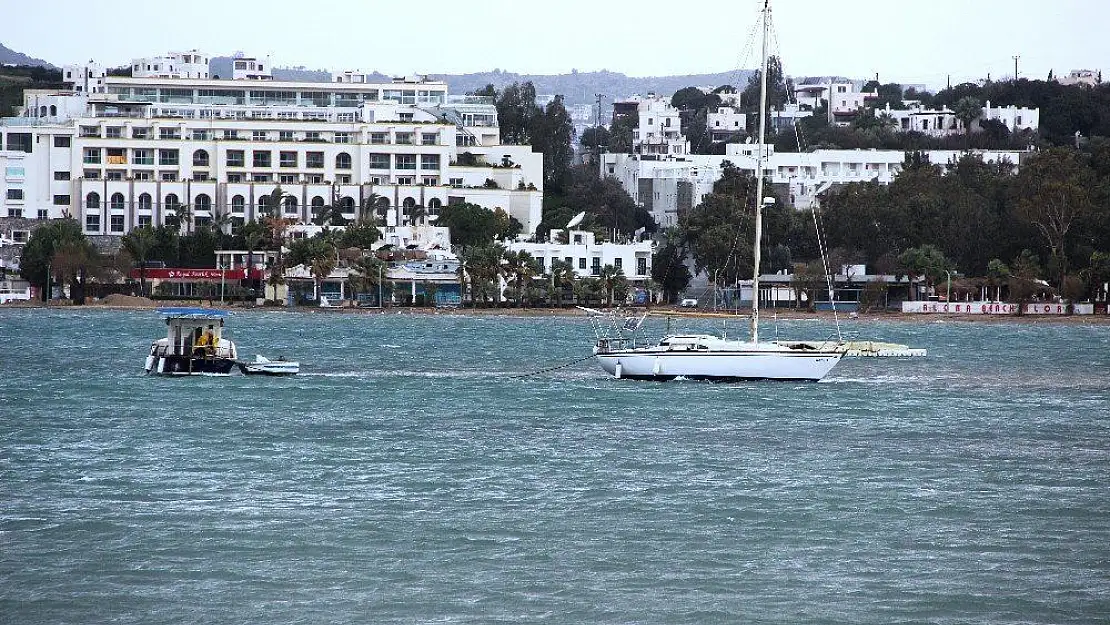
[0,58,543,235]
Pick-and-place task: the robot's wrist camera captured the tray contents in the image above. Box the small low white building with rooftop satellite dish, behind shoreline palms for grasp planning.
[507,230,652,283]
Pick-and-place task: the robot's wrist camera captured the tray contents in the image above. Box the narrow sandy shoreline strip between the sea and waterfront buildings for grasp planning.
[8,300,1110,325]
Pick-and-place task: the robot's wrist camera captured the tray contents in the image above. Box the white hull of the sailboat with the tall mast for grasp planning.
[597,350,842,382]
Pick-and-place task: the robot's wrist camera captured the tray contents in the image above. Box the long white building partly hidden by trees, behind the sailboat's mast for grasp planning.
[602,143,1028,222]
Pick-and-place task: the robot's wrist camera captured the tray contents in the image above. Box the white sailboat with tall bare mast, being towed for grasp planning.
[584,0,847,382]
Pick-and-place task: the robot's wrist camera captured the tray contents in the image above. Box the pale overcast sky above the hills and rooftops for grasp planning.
[0,0,1110,88]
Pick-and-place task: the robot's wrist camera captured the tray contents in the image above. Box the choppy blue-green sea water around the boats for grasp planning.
[0,309,1110,625]
